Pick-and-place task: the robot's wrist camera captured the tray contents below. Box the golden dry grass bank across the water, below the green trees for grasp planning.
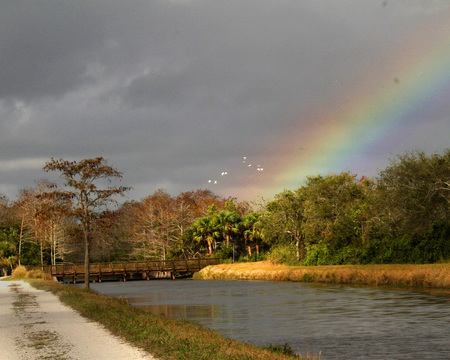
[195,262,450,290]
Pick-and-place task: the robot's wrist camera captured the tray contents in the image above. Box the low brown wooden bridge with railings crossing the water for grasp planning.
[39,259,222,283]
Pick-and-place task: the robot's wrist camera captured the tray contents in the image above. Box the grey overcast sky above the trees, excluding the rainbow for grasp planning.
[0,0,450,204]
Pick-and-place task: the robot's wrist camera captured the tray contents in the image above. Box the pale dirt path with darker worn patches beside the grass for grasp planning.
[0,281,155,360]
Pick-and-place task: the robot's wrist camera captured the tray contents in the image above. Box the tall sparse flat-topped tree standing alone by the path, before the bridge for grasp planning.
[43,157,129,288]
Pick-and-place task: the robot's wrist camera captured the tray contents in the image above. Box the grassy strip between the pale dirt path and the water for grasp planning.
[22,279,314,360]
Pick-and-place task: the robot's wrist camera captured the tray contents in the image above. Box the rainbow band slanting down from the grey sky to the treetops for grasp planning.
[243,10,450,199]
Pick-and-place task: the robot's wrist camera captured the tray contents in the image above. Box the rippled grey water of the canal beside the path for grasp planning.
[92,280,450,360]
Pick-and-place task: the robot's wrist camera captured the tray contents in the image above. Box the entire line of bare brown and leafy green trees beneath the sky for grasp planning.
[0,149,450,273]
